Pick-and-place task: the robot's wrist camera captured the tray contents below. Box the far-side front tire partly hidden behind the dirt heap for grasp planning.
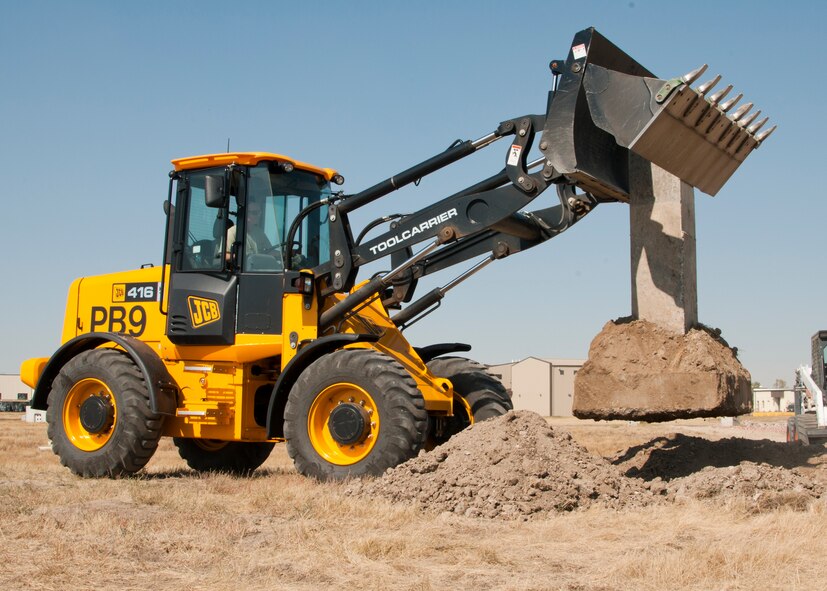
[428,357,514,445]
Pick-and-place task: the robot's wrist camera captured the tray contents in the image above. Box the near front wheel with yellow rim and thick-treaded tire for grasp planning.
[284,349,428,480]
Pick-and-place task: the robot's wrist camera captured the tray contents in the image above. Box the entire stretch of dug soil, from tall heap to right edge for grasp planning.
[346,411,824,520]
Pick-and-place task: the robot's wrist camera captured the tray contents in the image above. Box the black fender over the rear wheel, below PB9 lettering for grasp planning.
[32,332,178,415]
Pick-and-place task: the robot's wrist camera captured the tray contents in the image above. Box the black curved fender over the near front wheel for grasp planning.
[267,333,379,439]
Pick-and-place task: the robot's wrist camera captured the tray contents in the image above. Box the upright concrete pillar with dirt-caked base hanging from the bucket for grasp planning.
[573,154,752,421]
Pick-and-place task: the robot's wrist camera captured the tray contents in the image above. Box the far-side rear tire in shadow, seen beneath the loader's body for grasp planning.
[172,437,275,476]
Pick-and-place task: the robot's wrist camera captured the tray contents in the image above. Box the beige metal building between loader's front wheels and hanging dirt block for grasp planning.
[489,357,586,417]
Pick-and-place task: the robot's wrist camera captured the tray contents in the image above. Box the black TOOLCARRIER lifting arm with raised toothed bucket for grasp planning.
[314,29,775,327]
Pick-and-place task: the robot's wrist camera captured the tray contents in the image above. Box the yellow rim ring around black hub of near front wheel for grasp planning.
[307,383,379,466]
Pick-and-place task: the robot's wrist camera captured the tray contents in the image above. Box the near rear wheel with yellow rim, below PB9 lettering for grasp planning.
[46,349,163,478]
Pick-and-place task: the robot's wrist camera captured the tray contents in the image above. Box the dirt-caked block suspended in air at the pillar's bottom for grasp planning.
[573,318,752,421]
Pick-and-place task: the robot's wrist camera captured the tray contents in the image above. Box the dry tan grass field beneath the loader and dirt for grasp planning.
[0,413,827,591]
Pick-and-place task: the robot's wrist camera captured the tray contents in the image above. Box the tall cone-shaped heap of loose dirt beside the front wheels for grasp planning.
[349,411,653,519]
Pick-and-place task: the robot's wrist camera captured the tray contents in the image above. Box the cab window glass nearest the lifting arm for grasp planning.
[244,162,330,271]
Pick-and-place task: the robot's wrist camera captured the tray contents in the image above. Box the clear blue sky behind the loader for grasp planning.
[0,0,827,385]
